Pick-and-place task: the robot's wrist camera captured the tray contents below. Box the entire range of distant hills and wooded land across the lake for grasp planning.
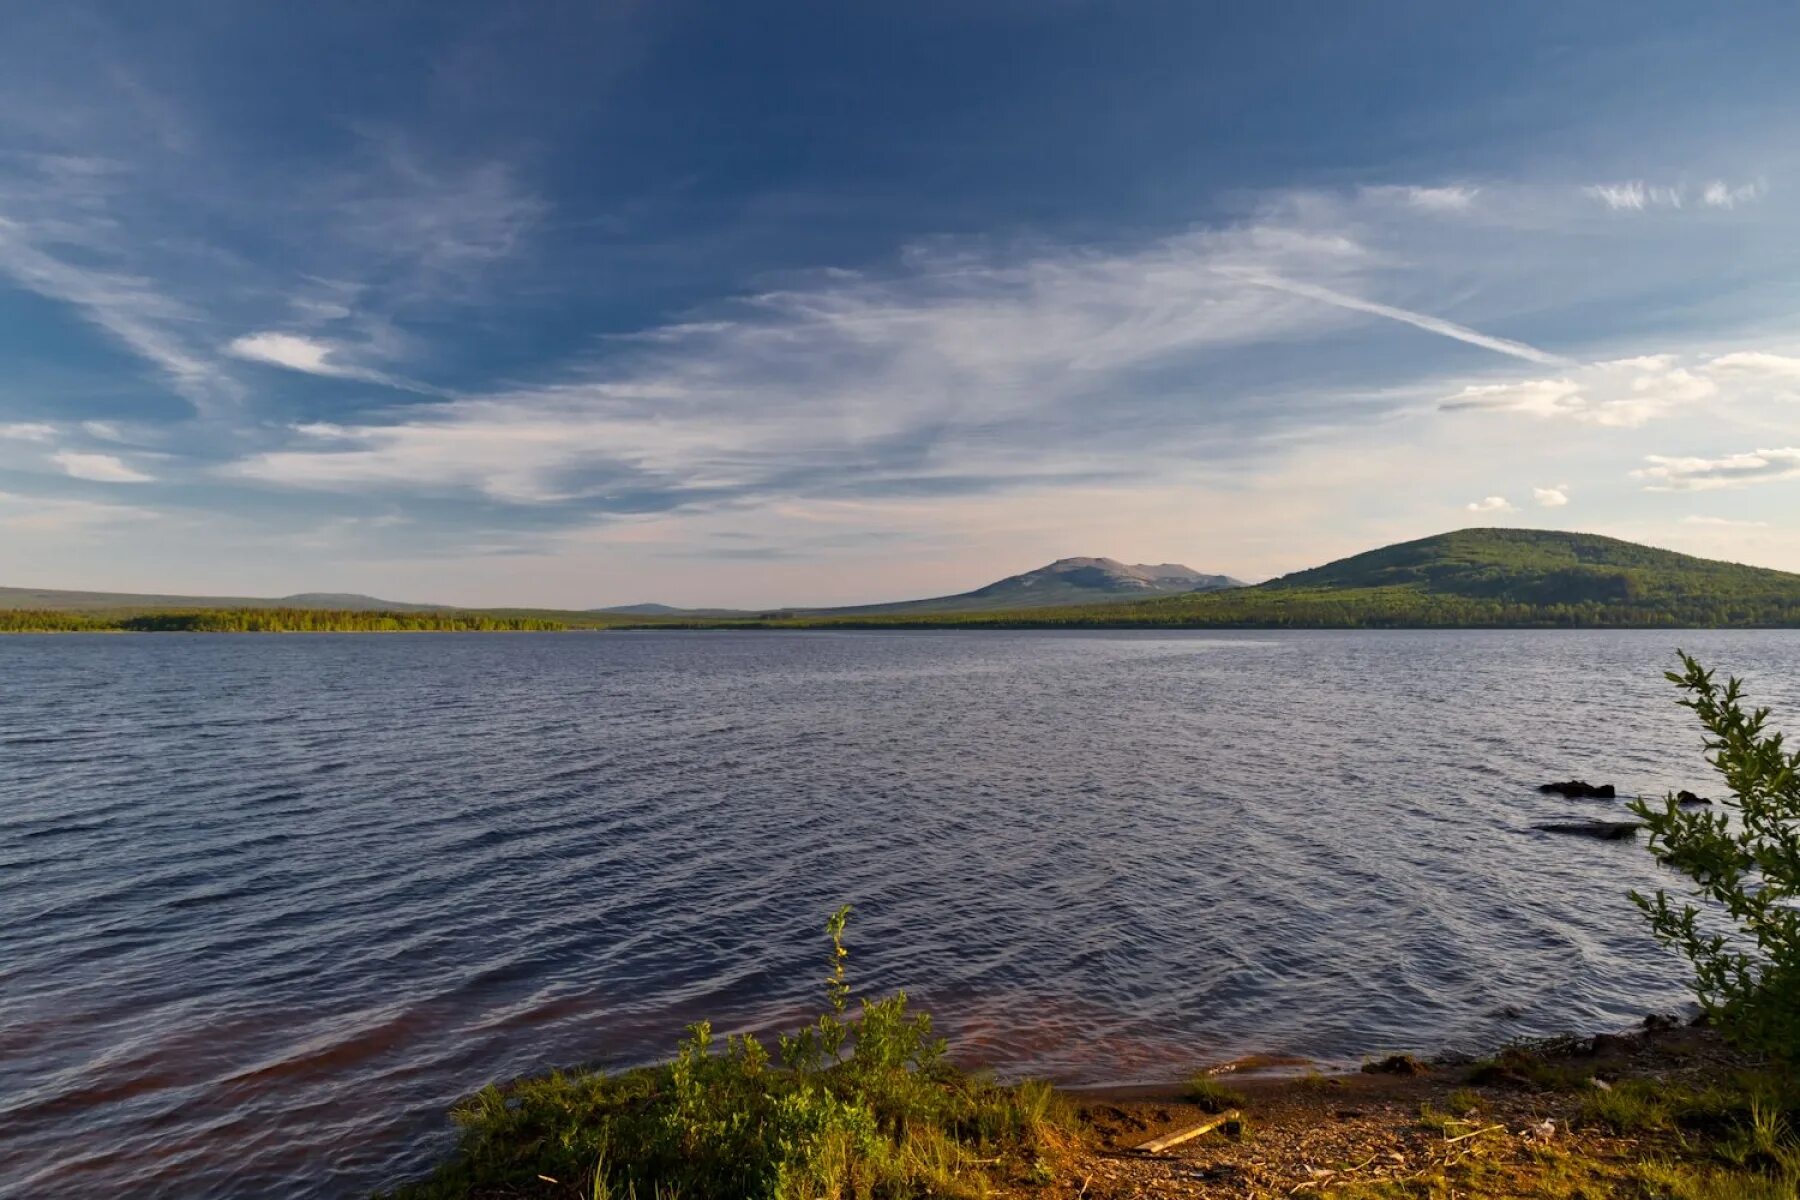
[14,529,1800,630]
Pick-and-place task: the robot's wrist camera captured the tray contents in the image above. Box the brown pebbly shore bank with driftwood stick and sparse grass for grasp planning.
[392,1018,1800,1200]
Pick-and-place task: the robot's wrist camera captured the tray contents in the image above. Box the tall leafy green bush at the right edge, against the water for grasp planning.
[1631,653,1800,1063]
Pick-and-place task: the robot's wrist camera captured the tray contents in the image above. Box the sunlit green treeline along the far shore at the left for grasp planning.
[0,608,569,633]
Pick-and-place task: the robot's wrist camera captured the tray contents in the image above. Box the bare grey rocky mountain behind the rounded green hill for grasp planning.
[794,558,1244,617]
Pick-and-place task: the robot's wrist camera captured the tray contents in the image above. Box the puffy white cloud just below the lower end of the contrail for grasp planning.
[1438,354,1719,428]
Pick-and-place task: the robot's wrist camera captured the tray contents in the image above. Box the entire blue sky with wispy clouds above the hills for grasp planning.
[0,0,1800,608]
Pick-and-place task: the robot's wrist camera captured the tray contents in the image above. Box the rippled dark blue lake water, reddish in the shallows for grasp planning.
[0,631,1800,1198]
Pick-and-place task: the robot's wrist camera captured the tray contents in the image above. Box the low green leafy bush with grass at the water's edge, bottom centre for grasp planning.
[392,907,1073,1200]
